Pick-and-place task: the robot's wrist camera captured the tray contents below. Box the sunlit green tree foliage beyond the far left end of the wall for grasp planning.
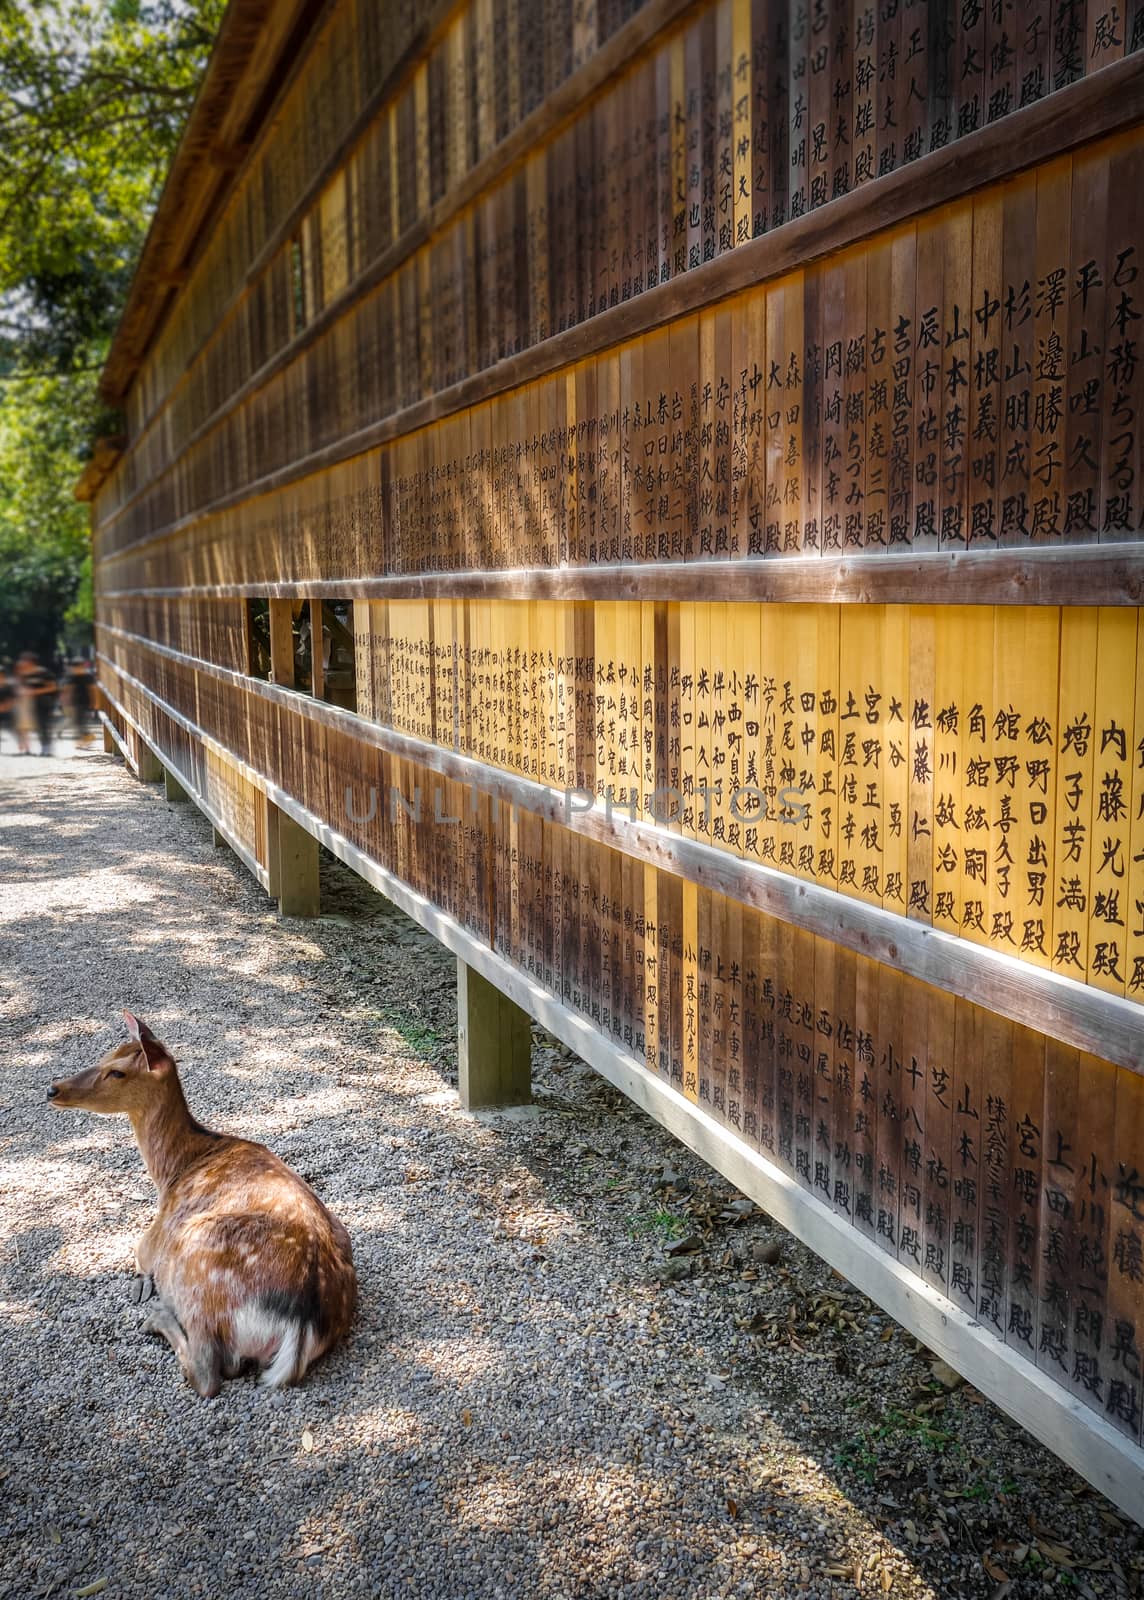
[0,0,224,656]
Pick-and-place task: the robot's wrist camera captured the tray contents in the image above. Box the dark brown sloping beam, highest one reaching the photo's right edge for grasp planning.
[102,53,1144,557]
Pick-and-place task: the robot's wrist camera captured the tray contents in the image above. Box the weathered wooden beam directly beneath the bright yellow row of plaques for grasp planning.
[101,624,1144,1075]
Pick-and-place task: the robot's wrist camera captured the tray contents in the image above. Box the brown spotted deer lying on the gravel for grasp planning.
[48,1011,357,1398]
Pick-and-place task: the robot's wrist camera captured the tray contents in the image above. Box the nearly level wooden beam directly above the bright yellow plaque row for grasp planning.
[99,542,1144,605]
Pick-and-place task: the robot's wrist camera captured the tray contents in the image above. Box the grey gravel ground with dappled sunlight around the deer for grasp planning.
[0,736,1144,1600]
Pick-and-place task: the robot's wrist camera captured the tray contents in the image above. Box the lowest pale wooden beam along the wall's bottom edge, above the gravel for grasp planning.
[91,675,1144,1523]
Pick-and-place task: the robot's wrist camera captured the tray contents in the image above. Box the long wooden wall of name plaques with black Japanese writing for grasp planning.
[94,0,1144,1515]
